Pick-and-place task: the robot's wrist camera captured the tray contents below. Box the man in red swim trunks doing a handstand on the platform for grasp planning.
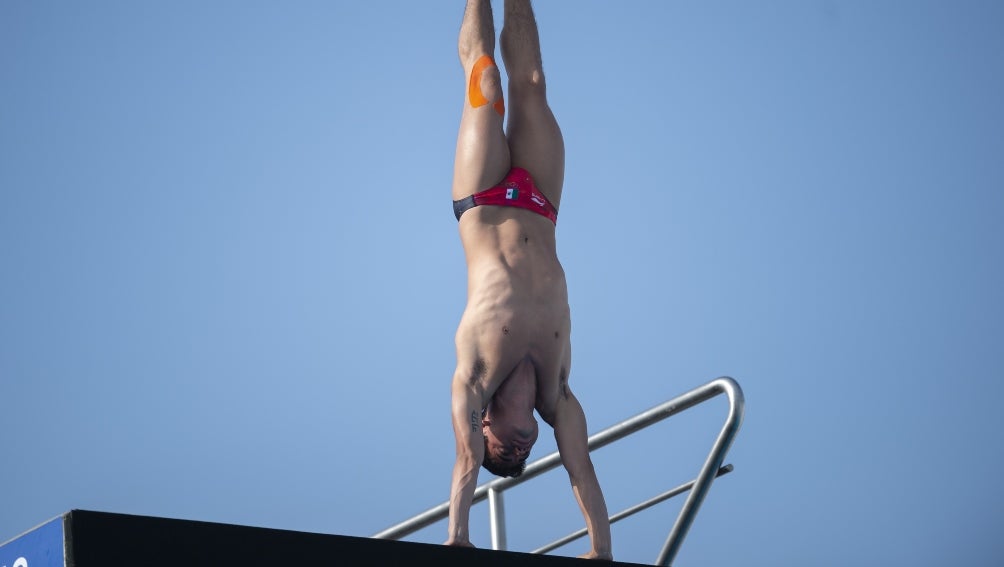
[446,0,611,559]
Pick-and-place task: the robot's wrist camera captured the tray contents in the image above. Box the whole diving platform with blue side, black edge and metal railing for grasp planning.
[0,376,744,567]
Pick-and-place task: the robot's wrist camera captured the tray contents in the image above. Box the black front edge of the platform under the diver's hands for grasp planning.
[64,510,646,567]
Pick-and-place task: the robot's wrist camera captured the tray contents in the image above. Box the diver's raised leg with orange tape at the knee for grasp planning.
[453,0,509,200]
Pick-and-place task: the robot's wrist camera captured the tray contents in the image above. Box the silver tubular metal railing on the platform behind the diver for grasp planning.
[372,376,745,565]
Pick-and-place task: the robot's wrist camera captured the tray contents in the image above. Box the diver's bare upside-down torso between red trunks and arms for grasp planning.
[457,207,571,422]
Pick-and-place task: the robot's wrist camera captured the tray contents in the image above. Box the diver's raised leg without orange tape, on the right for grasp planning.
[501,0,564,207]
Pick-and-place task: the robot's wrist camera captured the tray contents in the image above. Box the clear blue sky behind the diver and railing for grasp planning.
[0,0,1004,566]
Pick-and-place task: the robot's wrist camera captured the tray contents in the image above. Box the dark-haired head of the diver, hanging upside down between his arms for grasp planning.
[481,408,538,477]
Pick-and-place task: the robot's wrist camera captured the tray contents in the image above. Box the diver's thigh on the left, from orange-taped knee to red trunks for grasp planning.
[453,61,510,201]
